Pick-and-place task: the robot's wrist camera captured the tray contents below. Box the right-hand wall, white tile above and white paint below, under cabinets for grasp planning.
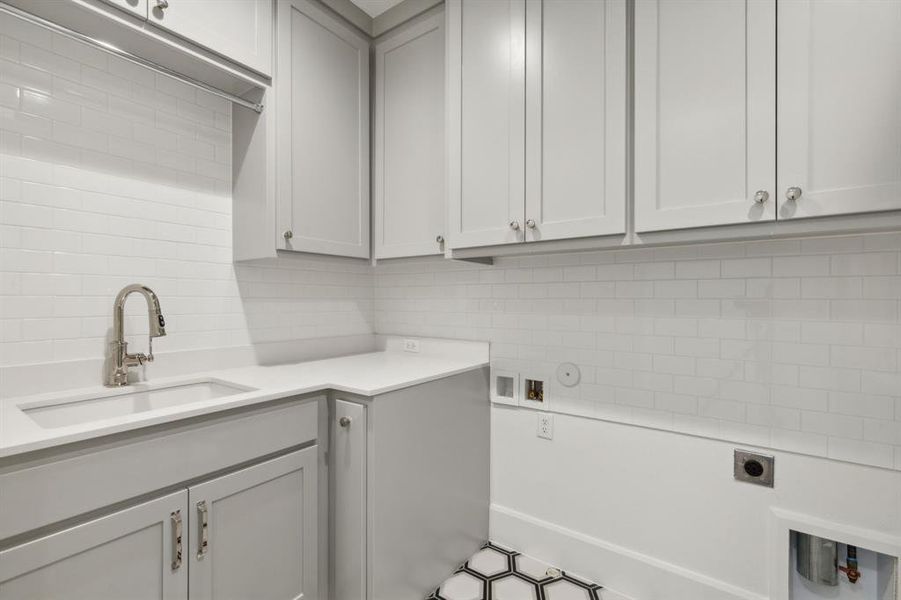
[375,245,901,600]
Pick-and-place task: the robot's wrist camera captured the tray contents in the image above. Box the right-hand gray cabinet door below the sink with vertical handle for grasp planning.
[188,446,318,600]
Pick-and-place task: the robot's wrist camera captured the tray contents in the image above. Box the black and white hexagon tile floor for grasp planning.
[426,542,602,600]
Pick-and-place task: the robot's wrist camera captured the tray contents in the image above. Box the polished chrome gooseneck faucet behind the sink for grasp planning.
[103,283,166,387]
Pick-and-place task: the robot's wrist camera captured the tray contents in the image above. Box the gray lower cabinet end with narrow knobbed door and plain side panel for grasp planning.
[330,369,491,600]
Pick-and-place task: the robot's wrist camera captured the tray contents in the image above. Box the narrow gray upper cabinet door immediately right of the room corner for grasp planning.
[373,12,446,258]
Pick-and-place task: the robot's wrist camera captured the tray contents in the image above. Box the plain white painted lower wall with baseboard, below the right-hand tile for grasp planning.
[491,407,901,600]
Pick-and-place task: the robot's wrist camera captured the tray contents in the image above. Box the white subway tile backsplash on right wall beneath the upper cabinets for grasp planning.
[375,234,901,468]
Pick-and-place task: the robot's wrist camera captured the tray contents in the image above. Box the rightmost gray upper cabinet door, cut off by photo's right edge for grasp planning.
[778,0,901,219]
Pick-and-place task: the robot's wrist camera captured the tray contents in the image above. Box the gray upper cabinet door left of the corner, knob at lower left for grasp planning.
[276,0,369,258]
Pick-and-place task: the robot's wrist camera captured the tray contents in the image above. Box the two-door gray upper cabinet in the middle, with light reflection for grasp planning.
[447,0,628,249]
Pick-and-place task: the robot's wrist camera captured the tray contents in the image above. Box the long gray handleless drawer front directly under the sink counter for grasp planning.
[0,396,324,540]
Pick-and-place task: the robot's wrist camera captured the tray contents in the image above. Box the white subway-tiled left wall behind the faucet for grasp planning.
[0,16,372,392]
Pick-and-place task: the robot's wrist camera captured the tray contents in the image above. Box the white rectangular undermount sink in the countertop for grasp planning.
[19,379,254,429]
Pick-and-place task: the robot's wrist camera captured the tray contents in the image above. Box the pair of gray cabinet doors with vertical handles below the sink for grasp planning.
[0,446,319,600]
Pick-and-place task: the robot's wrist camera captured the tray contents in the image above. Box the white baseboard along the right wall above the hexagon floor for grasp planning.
[490,504,767,600]
